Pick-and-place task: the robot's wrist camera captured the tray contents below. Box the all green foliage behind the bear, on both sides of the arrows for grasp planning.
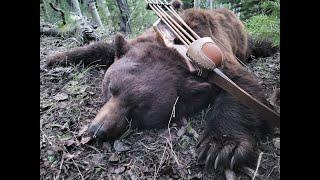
[40,0,280,46]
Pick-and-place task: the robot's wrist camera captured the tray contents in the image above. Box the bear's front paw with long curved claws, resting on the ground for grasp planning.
[197,133,254,170]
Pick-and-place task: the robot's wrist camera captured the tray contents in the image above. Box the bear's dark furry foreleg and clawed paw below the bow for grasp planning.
[197,91,264,170]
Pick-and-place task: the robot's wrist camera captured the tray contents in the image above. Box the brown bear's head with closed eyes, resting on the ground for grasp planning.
[89,35,215,139]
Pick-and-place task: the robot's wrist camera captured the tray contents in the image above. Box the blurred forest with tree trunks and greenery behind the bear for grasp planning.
[40,0,280,47]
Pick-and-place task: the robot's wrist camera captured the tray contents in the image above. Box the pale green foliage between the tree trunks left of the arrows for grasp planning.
[40,0,157,37]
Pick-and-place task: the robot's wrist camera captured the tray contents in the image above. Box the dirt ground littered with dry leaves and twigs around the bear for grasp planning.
[40,33,280,180]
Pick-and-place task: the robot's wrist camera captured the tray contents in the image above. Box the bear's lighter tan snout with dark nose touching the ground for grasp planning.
[89,98,128,140]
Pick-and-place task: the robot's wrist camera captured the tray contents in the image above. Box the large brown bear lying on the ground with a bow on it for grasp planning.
[47,5,278,176]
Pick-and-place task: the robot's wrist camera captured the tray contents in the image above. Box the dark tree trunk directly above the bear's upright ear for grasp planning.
[117,0,131,33]
